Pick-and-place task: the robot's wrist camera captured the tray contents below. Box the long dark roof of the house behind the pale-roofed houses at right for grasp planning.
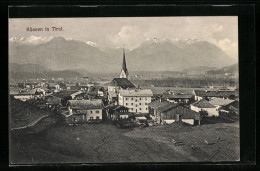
[194,90,235,97]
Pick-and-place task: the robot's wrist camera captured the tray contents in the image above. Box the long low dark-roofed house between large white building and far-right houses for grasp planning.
[163,94,194,104]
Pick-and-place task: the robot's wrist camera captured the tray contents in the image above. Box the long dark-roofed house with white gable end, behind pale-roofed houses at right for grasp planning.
[193,90,235,101]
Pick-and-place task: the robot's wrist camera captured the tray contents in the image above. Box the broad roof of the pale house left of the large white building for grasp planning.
[68,99,104,109]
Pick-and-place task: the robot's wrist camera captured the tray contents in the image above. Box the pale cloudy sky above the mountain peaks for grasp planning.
[9,16,238,60]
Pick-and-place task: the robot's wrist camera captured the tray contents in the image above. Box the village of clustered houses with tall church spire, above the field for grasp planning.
[10,48,239,129]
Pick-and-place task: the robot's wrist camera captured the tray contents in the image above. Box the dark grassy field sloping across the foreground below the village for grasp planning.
[10,119,239,164]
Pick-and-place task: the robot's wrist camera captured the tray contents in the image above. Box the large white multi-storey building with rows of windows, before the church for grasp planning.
[118,89,153,113]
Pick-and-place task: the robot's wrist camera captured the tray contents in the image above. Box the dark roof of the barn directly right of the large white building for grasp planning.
[148,100,178,112]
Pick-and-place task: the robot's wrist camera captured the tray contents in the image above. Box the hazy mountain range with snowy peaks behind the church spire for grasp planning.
[9,37,236,73]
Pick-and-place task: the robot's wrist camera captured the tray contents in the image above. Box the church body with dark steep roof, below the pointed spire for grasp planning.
[107,78,135,93]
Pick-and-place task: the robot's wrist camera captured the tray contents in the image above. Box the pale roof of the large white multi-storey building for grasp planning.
[119,89,153,97]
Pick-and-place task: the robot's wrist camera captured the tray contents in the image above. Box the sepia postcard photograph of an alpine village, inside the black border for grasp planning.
[8,16,242,165]
